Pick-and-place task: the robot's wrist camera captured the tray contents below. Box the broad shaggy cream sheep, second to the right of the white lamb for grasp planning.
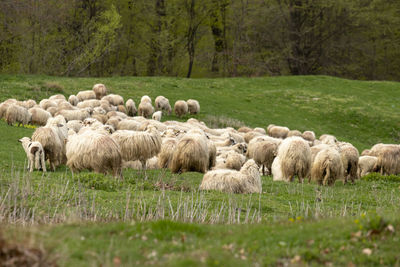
[66,130,122,178]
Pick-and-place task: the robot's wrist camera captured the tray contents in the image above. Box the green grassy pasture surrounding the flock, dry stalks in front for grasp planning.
[0,75,400,266]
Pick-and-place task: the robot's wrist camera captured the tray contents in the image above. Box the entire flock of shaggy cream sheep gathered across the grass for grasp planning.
[0,84,400,193]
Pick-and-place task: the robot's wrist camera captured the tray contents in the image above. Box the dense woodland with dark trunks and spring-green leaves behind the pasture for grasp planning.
[0,0,400,80]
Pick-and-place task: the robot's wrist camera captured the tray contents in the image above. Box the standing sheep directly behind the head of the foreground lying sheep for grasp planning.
[246,139,279,175]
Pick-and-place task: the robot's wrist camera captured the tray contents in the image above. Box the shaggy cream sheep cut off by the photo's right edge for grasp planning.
[370,144,400,175]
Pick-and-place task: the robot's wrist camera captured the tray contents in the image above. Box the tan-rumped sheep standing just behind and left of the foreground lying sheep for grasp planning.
[170,130,210,173]
